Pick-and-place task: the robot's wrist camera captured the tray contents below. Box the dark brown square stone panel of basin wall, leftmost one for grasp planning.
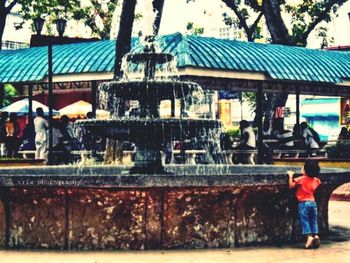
[8,188,66,249]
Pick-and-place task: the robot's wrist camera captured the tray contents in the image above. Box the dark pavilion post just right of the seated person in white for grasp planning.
[256,83,264,164]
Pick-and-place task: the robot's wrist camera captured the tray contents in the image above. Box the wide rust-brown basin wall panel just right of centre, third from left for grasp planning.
[163,188,237,248]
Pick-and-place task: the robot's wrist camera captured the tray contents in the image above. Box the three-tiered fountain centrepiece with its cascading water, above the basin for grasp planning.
[75,39,221,173]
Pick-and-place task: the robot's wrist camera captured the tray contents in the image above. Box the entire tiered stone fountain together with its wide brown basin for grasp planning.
[0,38,350,249]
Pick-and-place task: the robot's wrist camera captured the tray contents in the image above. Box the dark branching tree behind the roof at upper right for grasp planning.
[187,0,347,131]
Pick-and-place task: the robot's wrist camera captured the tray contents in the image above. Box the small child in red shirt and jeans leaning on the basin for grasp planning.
[287,160,321,248]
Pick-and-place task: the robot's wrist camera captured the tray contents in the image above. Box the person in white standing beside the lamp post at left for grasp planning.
[34,107,49,162]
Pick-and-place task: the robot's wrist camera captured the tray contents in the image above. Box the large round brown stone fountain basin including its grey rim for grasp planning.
[0,165,350,249]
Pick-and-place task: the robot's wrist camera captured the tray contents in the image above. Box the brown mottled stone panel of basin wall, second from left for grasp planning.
[69,190,147,249]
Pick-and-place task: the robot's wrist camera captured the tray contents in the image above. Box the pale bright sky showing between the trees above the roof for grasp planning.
[5,0,350,48]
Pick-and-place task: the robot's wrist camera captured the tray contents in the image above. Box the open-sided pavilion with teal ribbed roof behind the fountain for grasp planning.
[0,33,350,163]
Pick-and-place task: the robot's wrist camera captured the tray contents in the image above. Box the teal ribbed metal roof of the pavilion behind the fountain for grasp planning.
[0,33,350,83]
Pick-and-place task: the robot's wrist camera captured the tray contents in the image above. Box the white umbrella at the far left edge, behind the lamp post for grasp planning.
[0,98,59,116]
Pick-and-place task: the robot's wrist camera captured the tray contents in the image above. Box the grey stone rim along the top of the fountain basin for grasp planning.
[0,165,350,188]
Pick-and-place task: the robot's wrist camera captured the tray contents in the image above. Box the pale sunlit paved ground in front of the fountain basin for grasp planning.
[0,201,350,263]
